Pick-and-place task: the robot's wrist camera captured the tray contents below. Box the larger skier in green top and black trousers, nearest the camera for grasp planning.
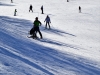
[33,17,43,39]
